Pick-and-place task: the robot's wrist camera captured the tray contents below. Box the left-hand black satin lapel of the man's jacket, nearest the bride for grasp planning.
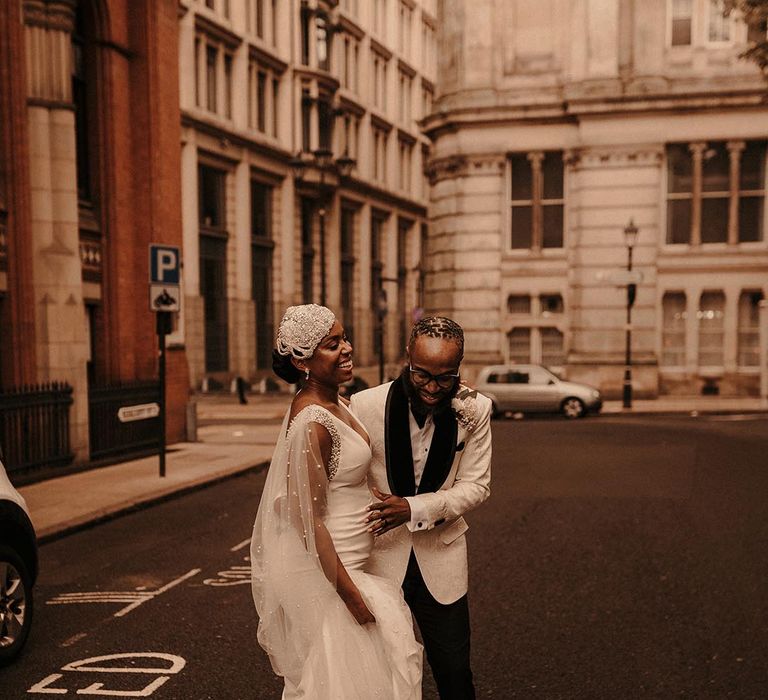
[384,380,416,497]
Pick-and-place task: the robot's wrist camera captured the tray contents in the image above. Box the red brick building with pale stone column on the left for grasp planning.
[0,0,188,474]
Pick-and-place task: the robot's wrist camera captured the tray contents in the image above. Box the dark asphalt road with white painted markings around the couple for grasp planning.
[0,416,768,700]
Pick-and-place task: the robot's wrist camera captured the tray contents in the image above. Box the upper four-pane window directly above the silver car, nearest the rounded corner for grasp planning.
[510,151,565,250]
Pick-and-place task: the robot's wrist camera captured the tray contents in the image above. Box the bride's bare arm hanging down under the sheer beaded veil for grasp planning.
[306,423,376,625]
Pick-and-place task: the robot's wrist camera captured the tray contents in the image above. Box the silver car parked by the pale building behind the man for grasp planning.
[476,365,603,418]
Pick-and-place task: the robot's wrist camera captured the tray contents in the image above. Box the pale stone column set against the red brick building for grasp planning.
[24,0,88,461]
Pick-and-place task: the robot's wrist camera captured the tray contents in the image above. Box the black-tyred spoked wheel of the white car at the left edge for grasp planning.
[0,545,32,666]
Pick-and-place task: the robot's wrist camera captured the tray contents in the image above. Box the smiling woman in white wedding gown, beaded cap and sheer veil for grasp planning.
[251,304,422,700]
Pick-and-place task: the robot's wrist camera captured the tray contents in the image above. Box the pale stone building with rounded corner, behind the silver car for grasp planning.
[425,0,768,396]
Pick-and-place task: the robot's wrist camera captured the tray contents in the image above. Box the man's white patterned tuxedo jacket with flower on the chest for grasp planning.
[351,380,491,605]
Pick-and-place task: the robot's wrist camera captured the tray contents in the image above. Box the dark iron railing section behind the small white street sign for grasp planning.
[88,381,160,461]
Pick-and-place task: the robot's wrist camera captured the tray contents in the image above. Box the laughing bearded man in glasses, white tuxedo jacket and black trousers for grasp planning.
[352,316,491,700]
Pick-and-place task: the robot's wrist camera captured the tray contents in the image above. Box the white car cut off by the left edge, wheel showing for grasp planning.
[0,461,37,666]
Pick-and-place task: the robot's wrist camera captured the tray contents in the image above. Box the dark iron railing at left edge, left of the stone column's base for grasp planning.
[0,382,74,474]
